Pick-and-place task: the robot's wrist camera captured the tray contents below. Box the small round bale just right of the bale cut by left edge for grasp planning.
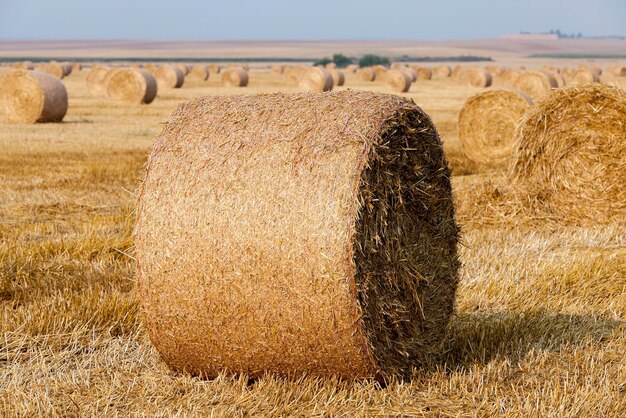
[106,68,157,104]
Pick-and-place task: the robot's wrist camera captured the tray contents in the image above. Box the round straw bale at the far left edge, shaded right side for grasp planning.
[0,70,68,125]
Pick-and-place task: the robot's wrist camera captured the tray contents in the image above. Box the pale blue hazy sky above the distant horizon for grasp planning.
[0,0,626,40]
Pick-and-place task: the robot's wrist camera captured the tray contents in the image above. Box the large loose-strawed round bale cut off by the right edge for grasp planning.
[513,83,626,221]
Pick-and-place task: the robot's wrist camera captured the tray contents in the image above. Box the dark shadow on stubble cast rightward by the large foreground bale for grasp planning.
[422,311,626,372]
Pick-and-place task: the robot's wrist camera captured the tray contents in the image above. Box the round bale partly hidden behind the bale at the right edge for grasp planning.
[457,90,532,167]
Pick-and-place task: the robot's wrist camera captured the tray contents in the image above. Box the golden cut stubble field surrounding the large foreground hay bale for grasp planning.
[0,70,626,417]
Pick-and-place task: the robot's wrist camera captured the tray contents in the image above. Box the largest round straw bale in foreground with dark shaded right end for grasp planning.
[135,91,459,380]
